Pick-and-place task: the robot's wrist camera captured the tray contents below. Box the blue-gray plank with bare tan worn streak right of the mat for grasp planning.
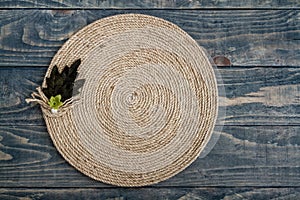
[0,67,300,125]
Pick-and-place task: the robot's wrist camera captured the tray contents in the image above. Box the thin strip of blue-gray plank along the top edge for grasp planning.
[0,0,300,9]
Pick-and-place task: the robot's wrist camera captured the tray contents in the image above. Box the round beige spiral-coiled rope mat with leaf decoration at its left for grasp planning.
[42,14,218,186]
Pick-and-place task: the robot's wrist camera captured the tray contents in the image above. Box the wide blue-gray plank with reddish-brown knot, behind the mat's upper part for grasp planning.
[0,9,300,66]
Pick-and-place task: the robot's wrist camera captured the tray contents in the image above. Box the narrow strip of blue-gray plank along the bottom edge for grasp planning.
[0,187,300,200]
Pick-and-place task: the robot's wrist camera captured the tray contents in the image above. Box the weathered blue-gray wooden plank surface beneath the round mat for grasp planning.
[0,0,300,200]
